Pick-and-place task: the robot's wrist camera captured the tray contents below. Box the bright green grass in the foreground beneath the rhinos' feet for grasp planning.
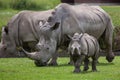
[0,57,120,80]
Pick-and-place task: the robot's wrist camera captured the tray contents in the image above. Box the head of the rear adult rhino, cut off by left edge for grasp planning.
[0,26,16,57]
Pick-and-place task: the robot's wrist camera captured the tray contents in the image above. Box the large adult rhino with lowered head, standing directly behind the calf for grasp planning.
[22,3,114,64]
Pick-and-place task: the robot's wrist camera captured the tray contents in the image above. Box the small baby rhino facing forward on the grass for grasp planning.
[68,33,100,73]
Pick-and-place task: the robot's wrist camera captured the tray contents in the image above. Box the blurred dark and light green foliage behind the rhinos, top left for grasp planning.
[0,0,60,10]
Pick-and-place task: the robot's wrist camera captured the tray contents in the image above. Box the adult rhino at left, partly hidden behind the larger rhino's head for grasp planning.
[0,10,52,57]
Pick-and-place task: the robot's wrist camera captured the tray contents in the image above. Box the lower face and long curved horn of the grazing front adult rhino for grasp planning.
[23,37,56,66]
